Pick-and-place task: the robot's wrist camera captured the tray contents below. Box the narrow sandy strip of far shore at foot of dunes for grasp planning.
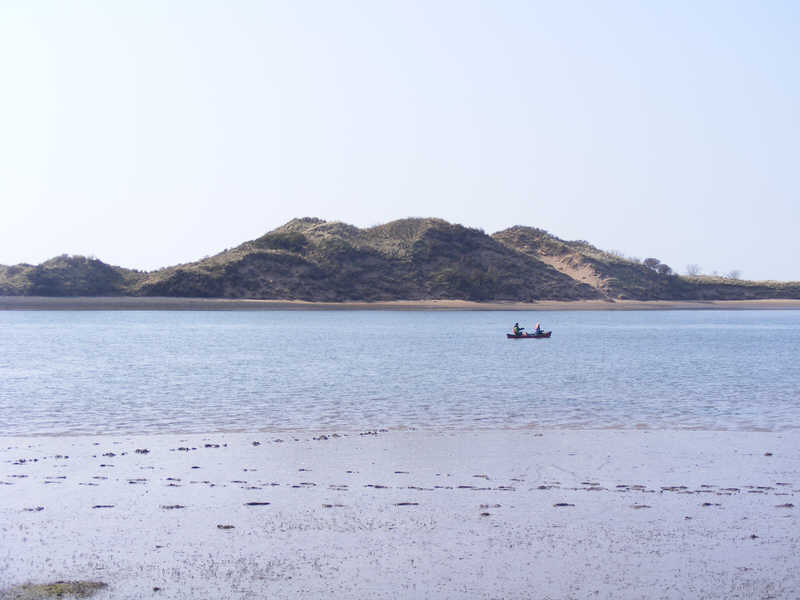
[0,296,800,311]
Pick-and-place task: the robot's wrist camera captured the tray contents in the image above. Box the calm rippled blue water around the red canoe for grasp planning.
[0,311,800,435]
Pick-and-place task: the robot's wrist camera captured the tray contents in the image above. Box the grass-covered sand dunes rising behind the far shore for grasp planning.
[0,218,800,302]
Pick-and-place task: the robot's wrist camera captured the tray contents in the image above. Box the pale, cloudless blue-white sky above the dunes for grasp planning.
[0,0,800,280]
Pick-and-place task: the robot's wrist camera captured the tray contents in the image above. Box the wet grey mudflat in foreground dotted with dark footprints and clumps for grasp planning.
[0,430,800,600]
